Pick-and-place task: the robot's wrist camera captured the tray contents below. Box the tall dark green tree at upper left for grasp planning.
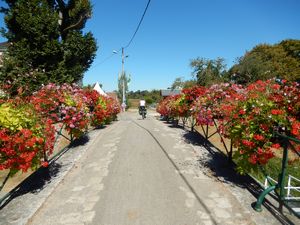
[0,0,97,95]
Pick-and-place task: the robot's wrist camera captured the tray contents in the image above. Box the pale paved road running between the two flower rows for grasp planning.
[0,112,292,225]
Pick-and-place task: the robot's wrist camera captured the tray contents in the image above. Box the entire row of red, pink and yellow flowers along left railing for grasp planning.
[0,84,120,178]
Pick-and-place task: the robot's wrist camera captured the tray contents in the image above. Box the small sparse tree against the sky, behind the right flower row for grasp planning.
[190,57,226,86]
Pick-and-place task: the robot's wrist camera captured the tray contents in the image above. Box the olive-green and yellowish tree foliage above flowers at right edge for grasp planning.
[228,40,300,83]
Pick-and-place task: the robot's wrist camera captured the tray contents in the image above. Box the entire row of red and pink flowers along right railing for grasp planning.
[157,80,300,173]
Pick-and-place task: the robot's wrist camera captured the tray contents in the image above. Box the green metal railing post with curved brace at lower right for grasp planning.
[254,132,300,218]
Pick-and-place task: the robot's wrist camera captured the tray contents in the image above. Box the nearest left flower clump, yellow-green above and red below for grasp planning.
[0,100,55,175]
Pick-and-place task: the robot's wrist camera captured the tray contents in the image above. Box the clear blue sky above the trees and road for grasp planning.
[1,0,300,91]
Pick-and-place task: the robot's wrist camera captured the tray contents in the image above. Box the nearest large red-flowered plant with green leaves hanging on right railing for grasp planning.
[223,80,296,173]
